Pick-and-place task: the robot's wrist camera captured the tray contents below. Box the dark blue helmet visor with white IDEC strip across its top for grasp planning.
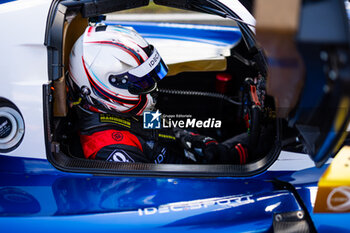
[111,45,168,95]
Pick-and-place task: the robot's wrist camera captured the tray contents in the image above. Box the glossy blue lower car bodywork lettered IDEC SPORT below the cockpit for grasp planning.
[0,150,350,232]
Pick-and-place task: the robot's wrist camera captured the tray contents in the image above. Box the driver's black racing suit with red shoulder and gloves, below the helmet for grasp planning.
[77,107,248,164]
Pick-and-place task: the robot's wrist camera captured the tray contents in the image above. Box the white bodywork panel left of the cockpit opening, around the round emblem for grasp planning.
[0,0,51,159]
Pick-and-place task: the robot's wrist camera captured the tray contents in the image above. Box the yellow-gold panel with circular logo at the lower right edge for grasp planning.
[314,146,350,213]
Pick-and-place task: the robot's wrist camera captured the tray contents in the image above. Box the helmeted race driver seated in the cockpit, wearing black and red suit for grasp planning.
[69,25,249,164]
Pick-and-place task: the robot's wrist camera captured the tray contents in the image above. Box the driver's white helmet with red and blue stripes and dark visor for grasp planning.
[69,25,168,116]
